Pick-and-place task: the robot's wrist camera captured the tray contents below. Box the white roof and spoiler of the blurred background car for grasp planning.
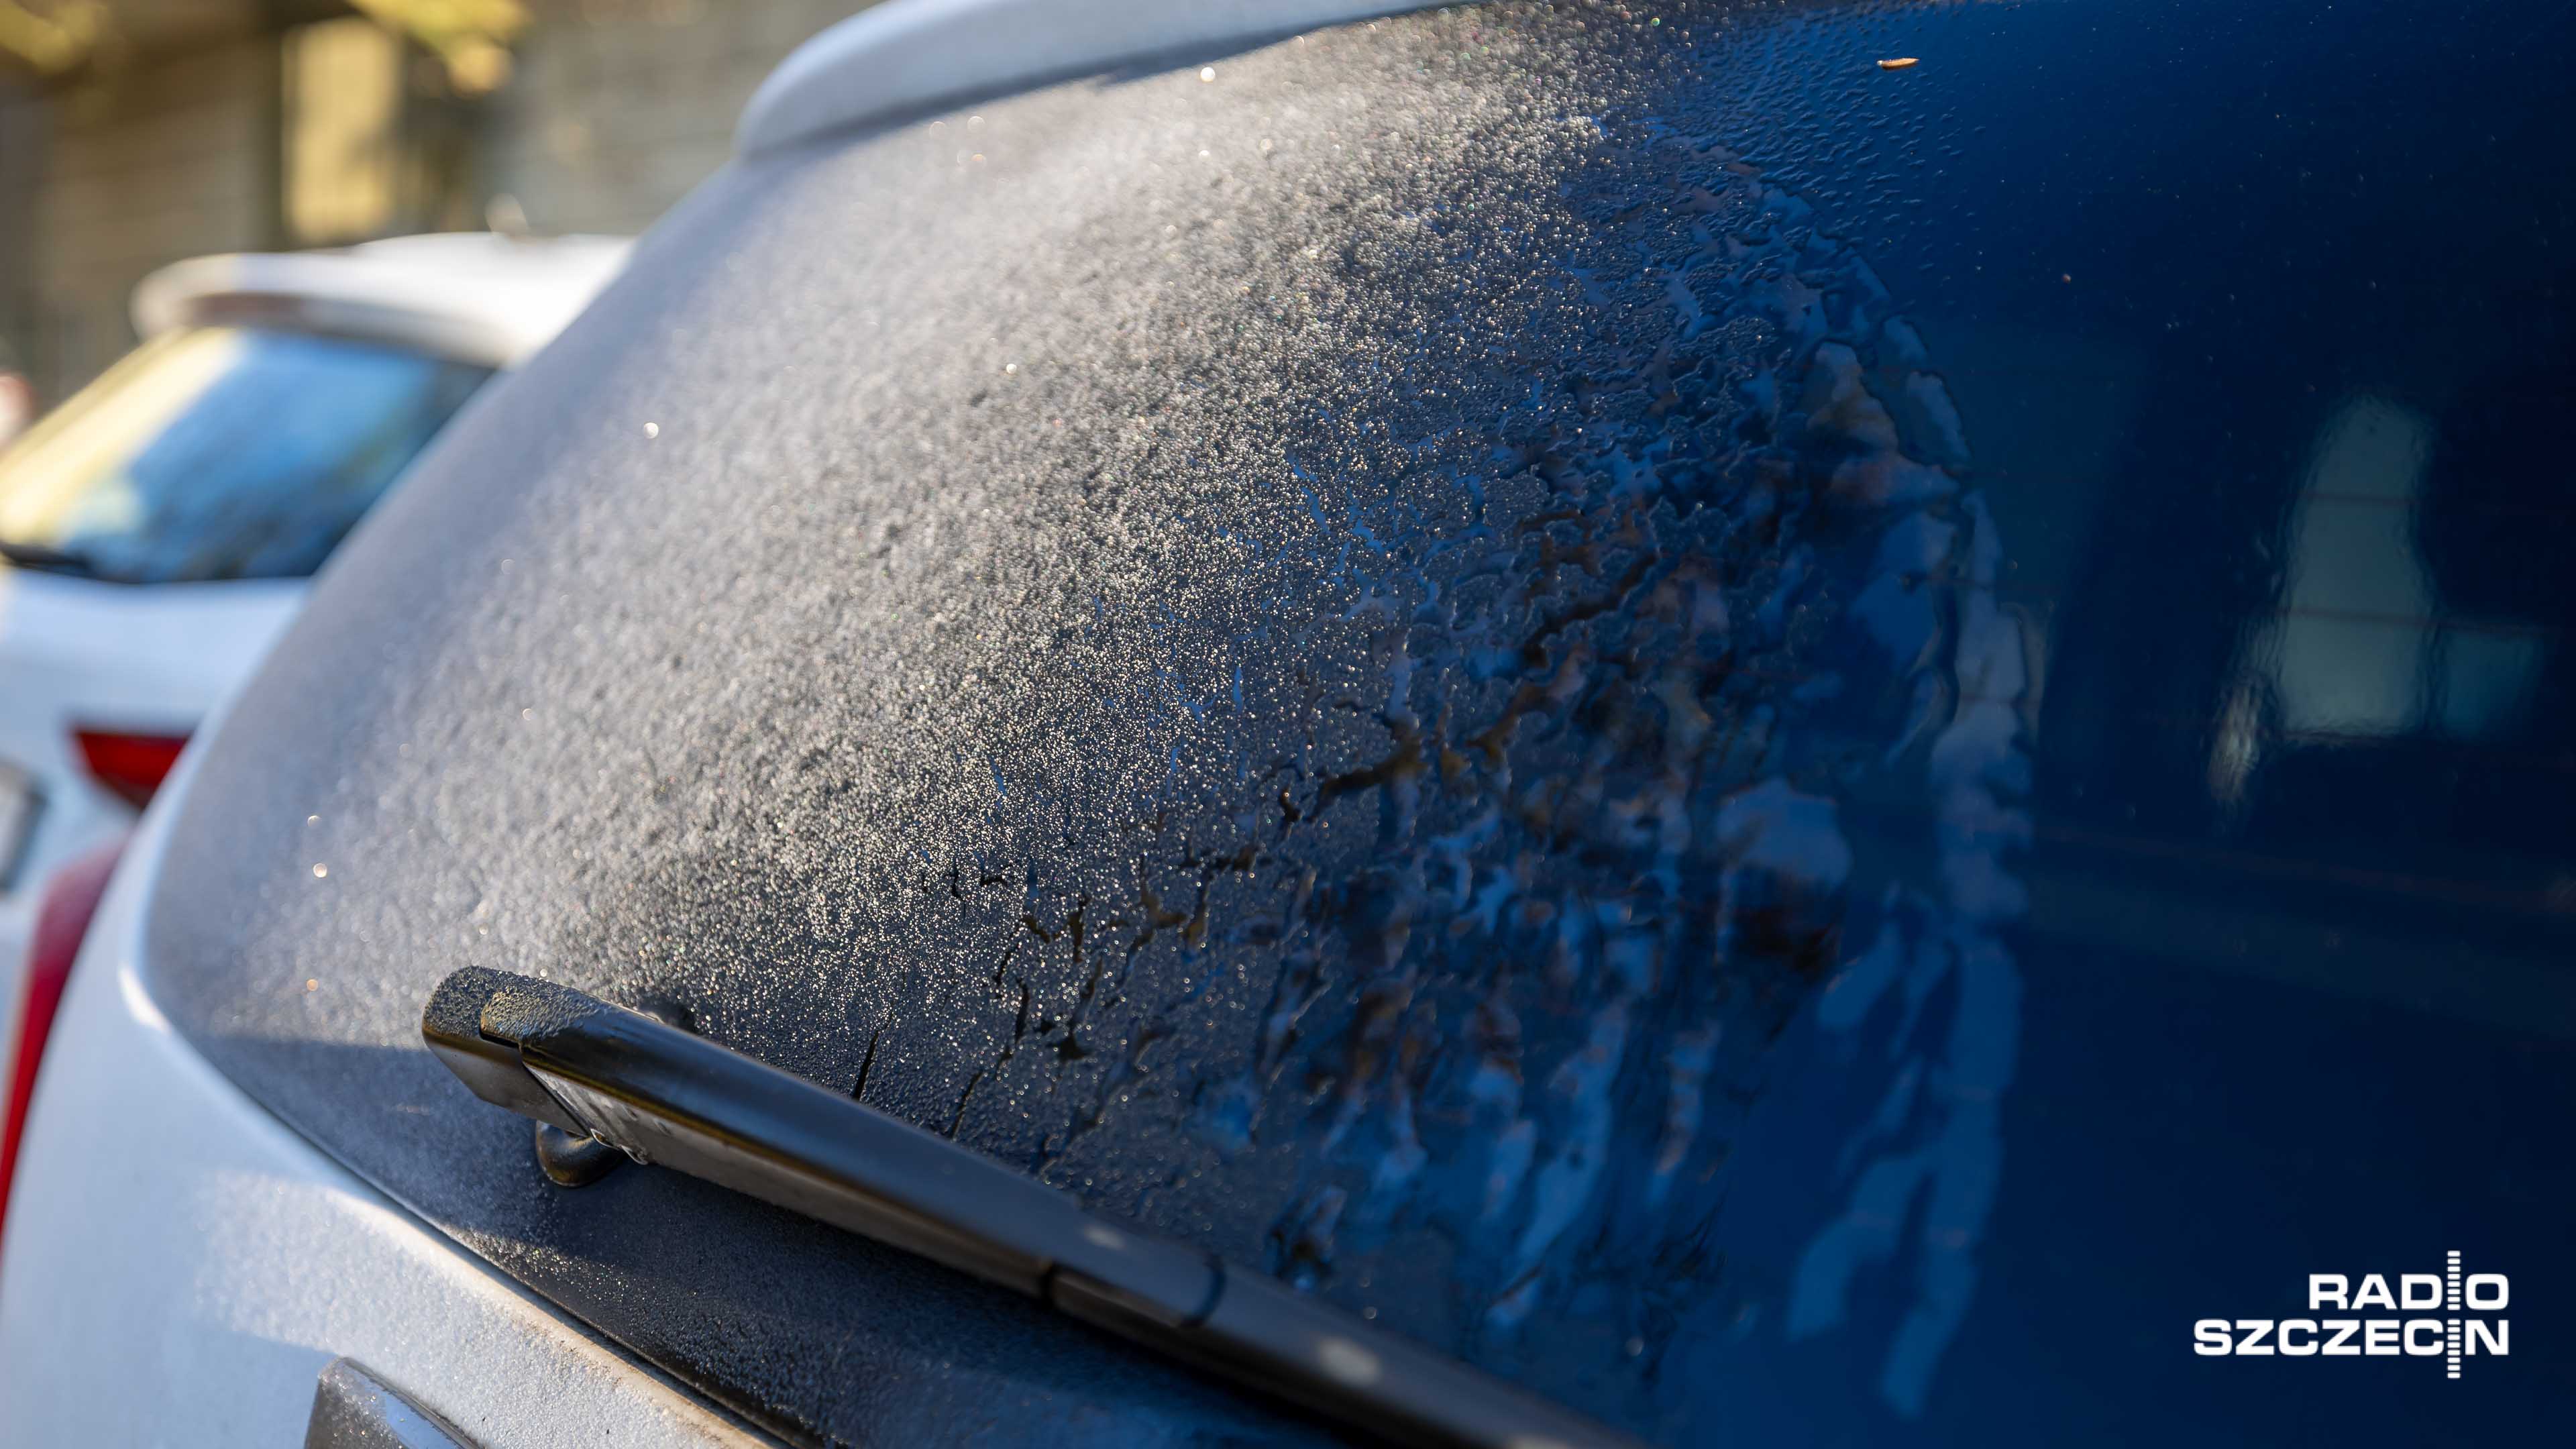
[134,232,631,366]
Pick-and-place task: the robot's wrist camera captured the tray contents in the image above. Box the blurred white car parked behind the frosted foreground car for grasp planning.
[0,235,626,1062]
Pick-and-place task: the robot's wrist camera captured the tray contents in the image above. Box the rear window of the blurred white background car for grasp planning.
[0,327,490,583]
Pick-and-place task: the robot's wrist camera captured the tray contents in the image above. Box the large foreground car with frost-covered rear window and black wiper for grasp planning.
[0,0,2576,1446]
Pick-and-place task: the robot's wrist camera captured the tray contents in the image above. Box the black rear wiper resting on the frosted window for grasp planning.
[420,967,1633,1449]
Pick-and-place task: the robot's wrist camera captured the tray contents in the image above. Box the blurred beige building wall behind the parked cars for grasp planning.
[0,0,865,402]
